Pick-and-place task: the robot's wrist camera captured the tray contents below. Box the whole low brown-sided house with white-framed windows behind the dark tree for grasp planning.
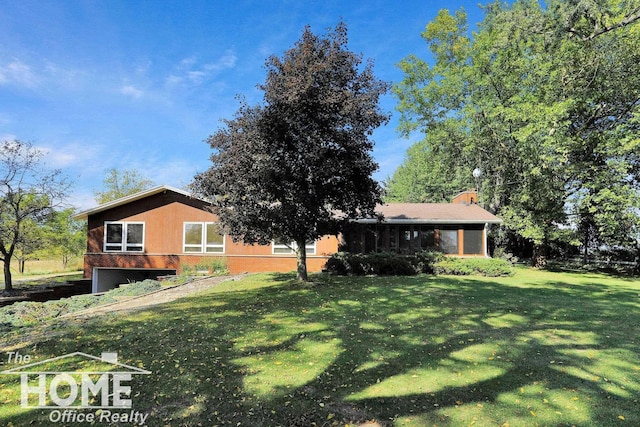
[75,186,500,292]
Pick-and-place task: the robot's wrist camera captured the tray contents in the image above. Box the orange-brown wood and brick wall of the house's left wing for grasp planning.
[84,191,338,278]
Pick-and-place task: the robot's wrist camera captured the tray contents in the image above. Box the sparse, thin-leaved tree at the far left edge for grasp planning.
[0,140,70,290]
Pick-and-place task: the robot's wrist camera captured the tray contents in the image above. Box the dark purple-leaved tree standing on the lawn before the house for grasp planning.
[194,23,388,280]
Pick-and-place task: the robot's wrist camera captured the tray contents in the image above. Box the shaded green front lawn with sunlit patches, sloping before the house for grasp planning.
[0,269,640,427]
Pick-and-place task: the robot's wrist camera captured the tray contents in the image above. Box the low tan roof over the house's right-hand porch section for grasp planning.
[356,203,502,224]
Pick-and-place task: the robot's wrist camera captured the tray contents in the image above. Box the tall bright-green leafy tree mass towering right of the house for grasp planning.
[390,0,640,262]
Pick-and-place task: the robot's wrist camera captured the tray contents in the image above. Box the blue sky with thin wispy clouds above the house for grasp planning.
[0,0,482,209]
